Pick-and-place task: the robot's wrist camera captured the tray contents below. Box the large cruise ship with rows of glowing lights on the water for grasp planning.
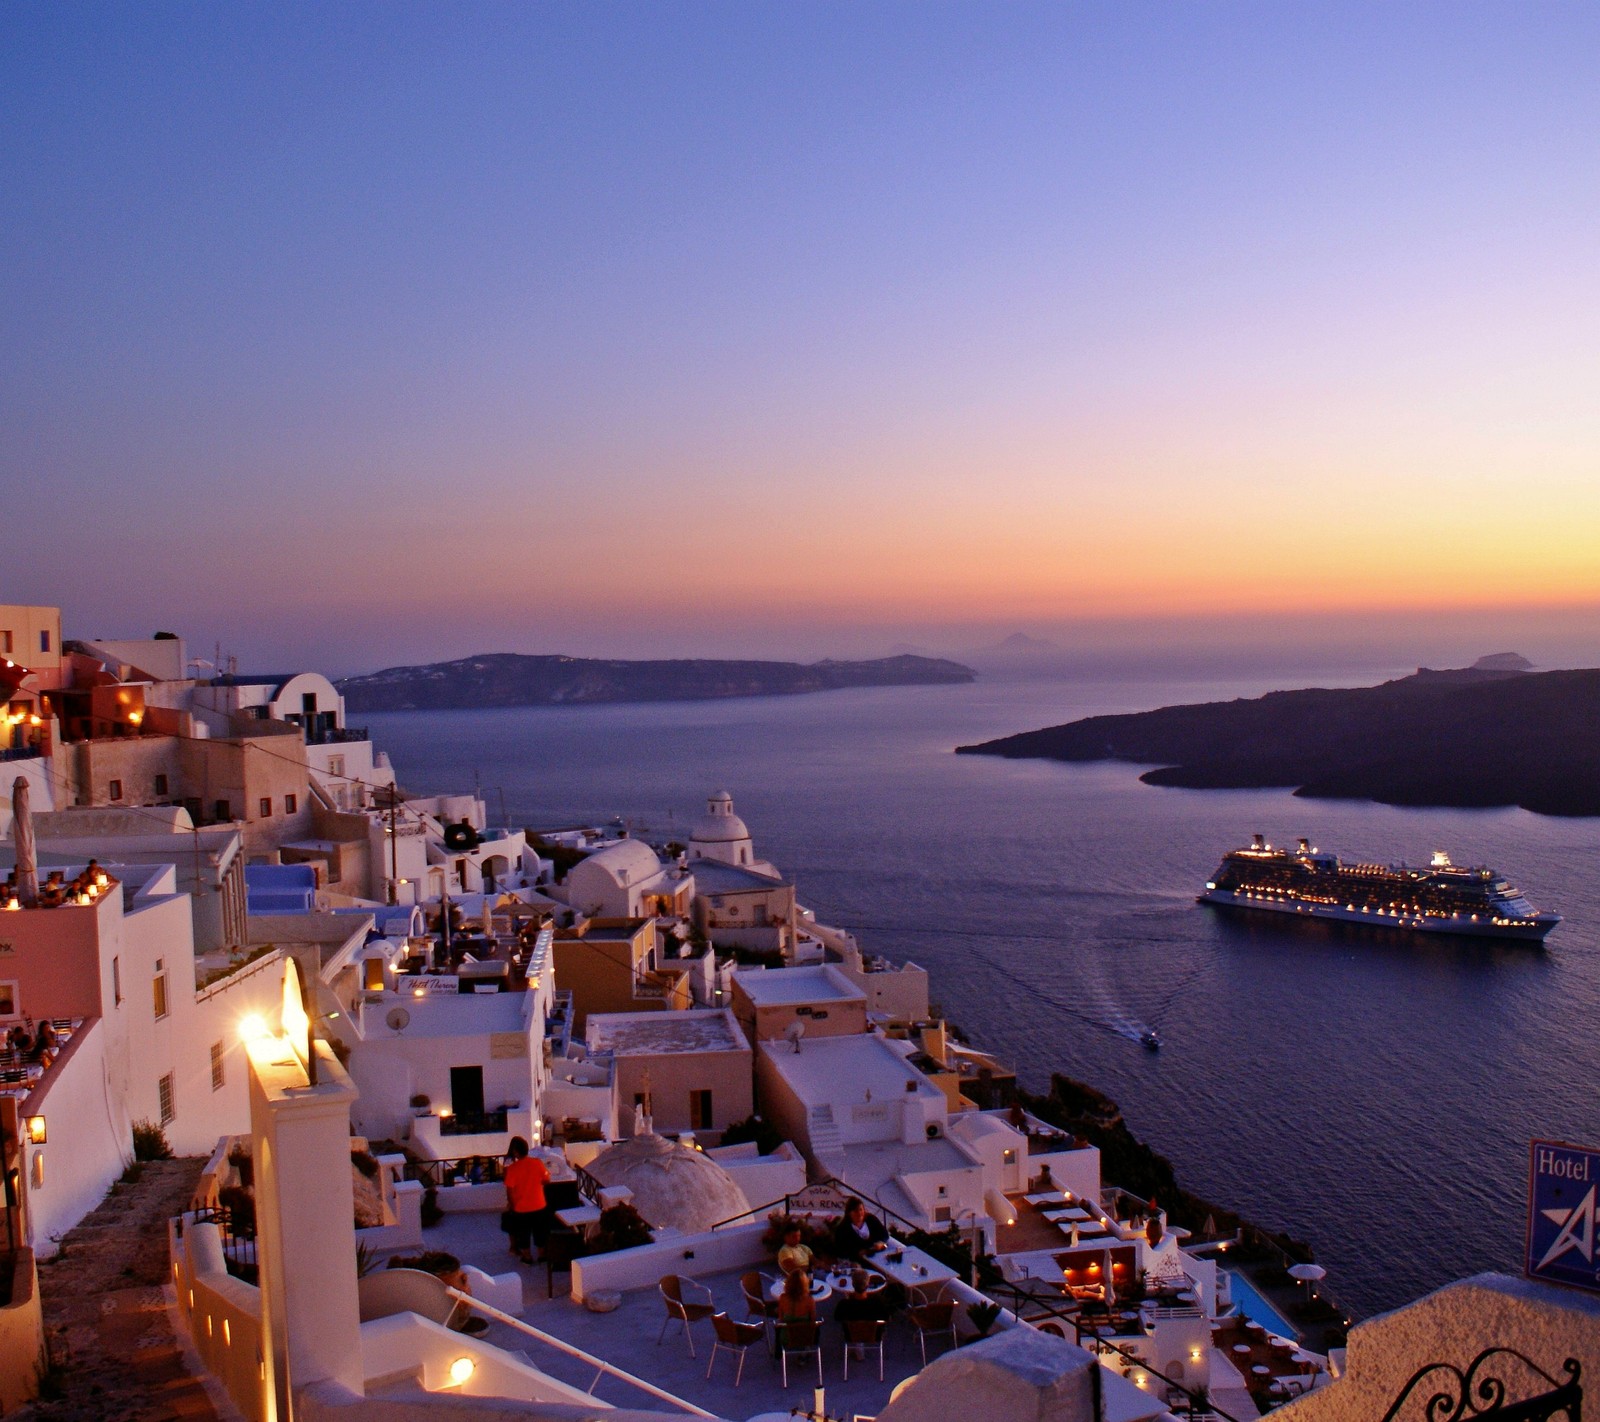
[1200,835,1562,939]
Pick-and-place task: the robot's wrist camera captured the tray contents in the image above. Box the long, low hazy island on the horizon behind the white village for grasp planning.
[338,653,976,712]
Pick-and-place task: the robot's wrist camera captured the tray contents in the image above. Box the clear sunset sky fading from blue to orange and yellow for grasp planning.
[0,0,1600,672]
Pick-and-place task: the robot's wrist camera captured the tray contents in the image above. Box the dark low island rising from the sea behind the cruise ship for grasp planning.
[957,653,1600,816]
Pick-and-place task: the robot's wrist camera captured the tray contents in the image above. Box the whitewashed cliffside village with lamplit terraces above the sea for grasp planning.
[0,606,1600,1422]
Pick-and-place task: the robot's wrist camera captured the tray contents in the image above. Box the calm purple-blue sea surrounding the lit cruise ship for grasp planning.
[366,669,1600,1315]
